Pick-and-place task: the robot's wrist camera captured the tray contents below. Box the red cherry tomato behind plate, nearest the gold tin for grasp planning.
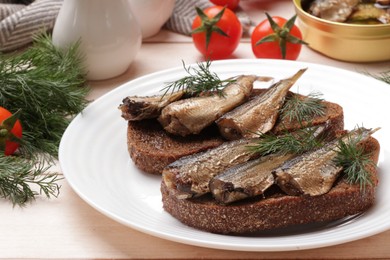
[251,14,307,60]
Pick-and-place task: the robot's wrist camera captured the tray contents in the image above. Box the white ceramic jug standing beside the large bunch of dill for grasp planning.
[52,0,142,80]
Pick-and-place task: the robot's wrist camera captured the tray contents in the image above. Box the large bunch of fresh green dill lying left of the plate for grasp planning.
[0,34,88,205]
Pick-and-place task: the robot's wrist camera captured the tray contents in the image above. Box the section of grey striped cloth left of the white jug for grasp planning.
[0,0,62,52]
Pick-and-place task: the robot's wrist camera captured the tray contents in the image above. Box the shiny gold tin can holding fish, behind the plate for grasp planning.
[293,0,390,62]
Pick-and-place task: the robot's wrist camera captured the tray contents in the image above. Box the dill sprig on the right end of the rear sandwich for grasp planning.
[280,92,326,123]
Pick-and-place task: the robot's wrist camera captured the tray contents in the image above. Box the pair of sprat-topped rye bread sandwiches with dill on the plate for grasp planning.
[119,63,380,234]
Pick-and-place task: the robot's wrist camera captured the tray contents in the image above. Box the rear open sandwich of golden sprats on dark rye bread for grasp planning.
[119,69,344,174]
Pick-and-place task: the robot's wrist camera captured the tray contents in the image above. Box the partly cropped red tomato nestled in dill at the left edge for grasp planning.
[0,107,22,155]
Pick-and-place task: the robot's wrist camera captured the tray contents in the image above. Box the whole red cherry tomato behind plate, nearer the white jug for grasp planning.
[192,6,242,60]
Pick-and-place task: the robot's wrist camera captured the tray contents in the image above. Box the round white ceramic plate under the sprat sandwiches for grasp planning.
[59,60,390,251]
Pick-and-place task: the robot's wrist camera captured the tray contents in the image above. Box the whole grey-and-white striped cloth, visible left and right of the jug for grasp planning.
[0,0,251,52]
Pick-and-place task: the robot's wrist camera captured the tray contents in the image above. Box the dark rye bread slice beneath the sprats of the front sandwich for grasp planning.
[161,137,380,234]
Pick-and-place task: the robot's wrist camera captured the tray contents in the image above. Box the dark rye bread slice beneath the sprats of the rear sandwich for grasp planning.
[127,89,344,174]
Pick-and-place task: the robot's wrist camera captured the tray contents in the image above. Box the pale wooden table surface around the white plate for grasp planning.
[0,0,390,259]
